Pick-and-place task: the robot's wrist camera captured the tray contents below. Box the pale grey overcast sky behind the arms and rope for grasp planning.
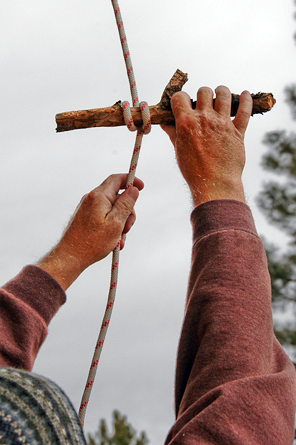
[0,0,296,445]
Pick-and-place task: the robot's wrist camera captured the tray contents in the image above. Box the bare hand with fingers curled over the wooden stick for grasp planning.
[162,86,252,206]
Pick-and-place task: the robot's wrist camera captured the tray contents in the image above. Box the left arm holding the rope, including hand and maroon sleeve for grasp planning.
[0,174,144,370]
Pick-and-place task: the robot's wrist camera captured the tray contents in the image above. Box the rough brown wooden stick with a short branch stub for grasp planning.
[56,70,276,132]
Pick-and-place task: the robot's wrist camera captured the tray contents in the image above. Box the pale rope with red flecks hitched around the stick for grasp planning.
[78,0,151,426]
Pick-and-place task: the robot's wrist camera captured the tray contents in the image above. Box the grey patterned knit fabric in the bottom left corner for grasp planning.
[0,368,86,445]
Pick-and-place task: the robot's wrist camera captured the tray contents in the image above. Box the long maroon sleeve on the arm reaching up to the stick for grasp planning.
[166,200,296,445]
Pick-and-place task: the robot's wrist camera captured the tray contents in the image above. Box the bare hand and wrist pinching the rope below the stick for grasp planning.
[37,174,144,290]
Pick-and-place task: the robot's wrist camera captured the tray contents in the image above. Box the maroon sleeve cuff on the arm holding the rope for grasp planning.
[0,266,66,371]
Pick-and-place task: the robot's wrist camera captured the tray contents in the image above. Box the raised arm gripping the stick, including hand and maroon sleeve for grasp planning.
[164,87,296,445]
